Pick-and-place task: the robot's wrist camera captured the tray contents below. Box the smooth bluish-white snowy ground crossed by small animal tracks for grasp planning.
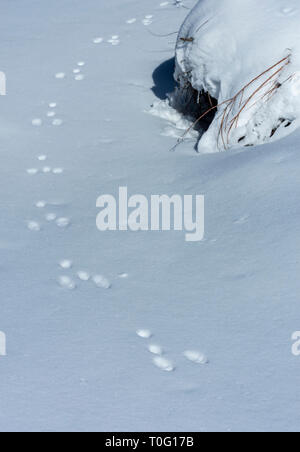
[0,0,300,431]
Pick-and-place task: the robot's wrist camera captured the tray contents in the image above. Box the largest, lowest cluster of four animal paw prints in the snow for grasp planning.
[136,329,209,372]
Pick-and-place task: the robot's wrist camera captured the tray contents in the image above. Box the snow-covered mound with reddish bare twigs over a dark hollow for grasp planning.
[175,0,300,152]
